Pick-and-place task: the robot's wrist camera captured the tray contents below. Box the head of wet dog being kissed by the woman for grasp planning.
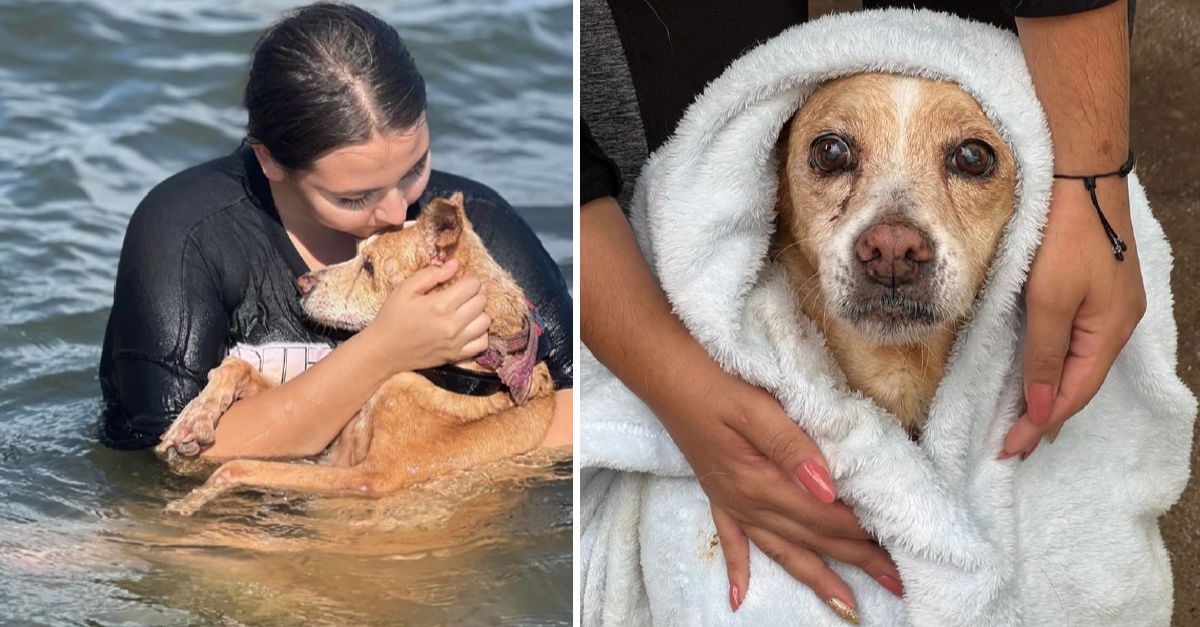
[296,193,472,332]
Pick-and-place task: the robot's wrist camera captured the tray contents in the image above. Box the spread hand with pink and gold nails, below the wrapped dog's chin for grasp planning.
[672,356,901,610]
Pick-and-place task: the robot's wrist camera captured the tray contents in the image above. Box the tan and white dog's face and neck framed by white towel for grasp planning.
[770,74,1016,432]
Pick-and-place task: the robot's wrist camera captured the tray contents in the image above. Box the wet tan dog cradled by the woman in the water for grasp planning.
[155,193,554,515]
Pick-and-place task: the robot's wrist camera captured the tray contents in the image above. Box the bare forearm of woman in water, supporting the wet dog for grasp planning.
[204,328,391,459]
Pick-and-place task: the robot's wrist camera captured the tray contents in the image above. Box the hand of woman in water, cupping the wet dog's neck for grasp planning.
[361,259,492,374]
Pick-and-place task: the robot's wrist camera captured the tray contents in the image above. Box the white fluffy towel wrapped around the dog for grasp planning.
[577,10,1196,626]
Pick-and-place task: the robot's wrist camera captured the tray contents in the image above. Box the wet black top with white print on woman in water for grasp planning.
[100,145,574,448]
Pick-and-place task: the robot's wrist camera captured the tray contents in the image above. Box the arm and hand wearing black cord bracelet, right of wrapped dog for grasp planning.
[1001,0,1146,459]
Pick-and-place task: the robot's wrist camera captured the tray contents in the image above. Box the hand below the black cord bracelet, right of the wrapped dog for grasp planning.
[1000,179,1146,459]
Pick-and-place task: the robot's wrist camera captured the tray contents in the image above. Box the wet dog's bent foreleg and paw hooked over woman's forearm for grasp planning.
[154,356,275,472]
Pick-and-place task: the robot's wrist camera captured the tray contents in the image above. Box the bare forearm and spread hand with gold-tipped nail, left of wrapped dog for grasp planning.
[580,198,900,610]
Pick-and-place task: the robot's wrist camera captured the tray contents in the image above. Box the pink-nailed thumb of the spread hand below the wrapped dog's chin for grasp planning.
[730,389,838,503]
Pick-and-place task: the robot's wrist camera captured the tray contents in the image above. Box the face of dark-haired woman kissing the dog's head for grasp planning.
[257,119,430,239]
